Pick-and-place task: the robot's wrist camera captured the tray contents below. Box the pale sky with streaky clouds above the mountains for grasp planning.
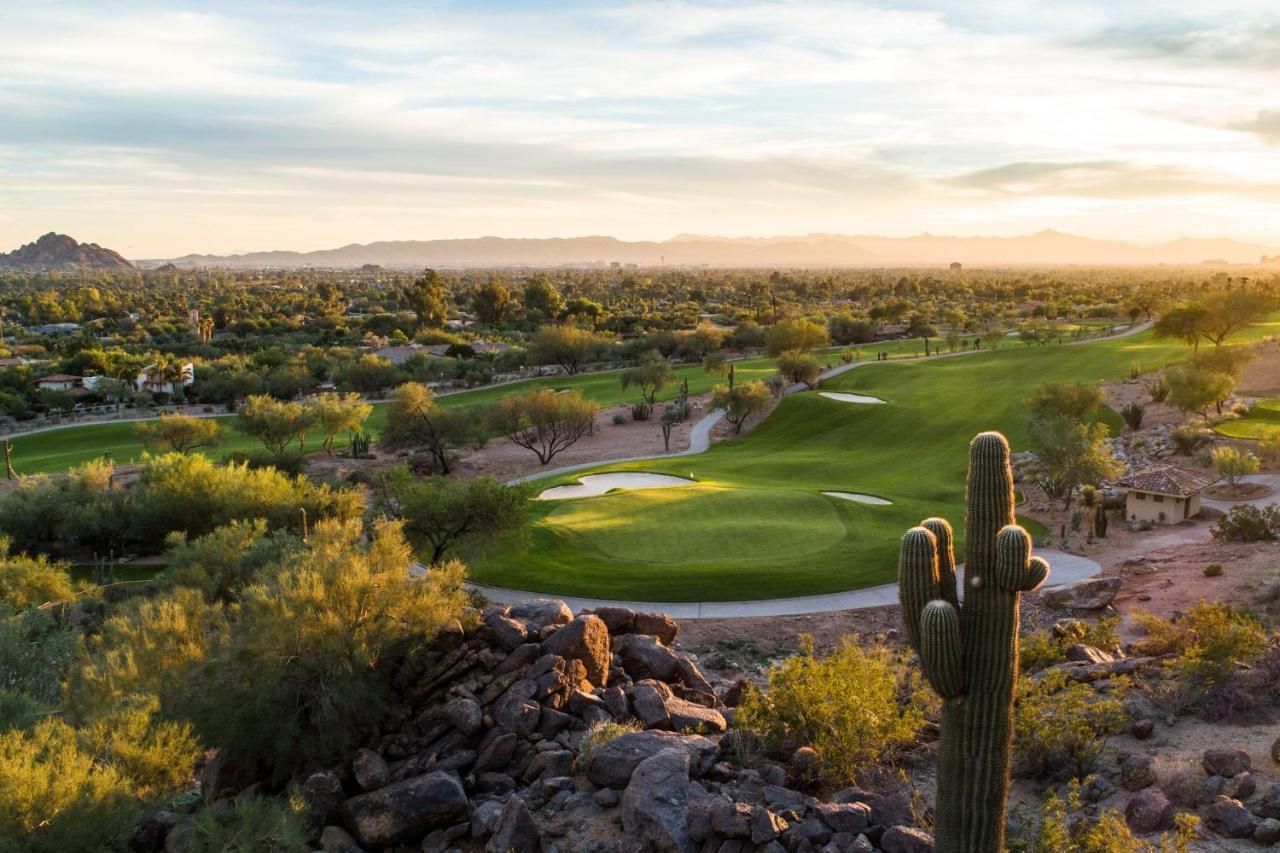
[0,0,1280,257]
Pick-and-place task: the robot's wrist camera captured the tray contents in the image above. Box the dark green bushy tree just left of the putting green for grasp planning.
[374,466,529,565]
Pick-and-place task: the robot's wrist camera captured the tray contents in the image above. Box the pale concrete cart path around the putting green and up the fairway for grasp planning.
[473,321,1153,619]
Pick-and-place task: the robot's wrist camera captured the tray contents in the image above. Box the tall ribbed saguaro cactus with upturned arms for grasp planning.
[897,433,1048,853]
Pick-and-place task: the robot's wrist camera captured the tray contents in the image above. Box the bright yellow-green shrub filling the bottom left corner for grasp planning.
[0,717,140,853]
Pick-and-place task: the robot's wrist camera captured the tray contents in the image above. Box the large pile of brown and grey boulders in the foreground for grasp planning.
[166,601,933,853]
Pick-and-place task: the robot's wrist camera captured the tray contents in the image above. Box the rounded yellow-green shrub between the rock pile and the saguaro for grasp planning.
[736,639,927,785]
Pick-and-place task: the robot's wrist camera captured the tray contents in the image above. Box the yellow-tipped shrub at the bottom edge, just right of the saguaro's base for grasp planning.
[1009,783,1199,853]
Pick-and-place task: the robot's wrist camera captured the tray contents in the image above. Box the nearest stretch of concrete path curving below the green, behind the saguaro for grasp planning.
[467,549,1102,619]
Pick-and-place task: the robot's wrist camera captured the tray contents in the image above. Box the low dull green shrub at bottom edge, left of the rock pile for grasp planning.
[182,797,311,853]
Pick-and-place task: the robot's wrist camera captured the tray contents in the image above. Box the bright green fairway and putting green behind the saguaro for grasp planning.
[471,315,1280,601]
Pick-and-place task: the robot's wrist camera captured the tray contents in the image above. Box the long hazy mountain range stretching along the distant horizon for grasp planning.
[152,231,1277,269]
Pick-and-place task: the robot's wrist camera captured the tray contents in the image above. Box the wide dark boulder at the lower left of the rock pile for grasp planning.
[343,772,467,847]
